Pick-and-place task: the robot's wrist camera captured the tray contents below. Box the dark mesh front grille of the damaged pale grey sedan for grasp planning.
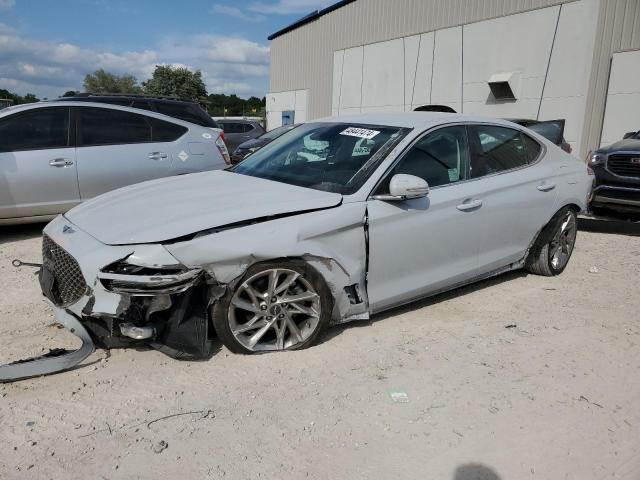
[42,235,87,307]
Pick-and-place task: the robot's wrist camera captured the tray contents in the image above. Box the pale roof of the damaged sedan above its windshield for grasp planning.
[313,112,519,129]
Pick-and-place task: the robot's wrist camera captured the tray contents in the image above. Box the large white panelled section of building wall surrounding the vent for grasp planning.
[332,0,596,156]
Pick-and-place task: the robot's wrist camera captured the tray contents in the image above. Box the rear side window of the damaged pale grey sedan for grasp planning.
[470,125,541,178]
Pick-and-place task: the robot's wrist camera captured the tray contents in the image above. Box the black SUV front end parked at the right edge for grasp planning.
[589,131,640,214]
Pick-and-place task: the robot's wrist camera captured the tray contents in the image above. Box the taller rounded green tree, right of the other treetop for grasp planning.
[142,65,207,101]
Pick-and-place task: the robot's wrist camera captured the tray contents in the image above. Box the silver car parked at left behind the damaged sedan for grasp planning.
[0,101,229,225]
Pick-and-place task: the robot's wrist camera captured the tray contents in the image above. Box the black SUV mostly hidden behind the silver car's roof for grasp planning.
[56,93,220,128]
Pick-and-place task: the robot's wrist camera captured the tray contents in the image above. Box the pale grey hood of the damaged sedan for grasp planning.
[65,170,342,245]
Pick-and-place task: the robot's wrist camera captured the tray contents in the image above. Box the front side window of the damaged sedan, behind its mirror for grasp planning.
[389,125,469,187]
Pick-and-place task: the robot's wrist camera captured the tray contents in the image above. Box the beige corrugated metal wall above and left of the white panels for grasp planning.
[269,0,572,118]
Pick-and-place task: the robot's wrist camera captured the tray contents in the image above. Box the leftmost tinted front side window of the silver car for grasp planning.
[0,107,70,152]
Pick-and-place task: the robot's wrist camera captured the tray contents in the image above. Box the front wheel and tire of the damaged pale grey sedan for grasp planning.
[212,260,333,354]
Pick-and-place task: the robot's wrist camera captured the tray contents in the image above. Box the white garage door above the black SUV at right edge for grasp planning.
[600,50,640,145]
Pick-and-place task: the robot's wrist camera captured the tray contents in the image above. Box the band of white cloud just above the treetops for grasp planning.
[0,25,269,98]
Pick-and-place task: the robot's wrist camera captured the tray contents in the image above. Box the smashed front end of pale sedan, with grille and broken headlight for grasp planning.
[40,216,215,366]
